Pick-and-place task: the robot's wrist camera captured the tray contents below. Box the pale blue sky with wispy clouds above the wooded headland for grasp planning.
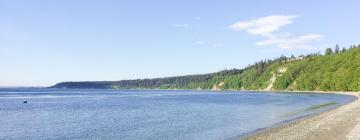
[0,0,360,86]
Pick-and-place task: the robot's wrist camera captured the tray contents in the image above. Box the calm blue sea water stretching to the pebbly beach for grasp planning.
[0,89,353,140]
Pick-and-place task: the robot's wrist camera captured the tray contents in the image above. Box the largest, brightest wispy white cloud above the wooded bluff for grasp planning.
[229,15,323,49]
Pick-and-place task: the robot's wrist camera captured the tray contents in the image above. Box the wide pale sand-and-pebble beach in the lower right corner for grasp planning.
[243,92,360,140]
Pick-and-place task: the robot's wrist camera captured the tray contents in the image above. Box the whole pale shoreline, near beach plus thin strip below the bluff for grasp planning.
[2,89,360,140]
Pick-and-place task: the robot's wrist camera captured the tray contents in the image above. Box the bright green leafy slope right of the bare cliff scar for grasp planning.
[274,44,360,91]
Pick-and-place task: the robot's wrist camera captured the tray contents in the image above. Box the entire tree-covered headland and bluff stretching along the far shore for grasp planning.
[51,45,360,91]
